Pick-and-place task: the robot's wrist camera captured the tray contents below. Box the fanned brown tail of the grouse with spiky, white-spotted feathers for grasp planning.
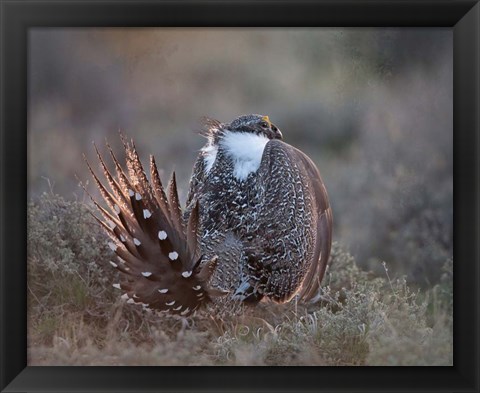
[84,135,225,316]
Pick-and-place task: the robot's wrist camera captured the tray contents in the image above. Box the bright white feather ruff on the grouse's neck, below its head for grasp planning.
[203,132,269,181]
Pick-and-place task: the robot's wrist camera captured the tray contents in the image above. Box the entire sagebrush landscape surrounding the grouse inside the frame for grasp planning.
[28,28,453,365]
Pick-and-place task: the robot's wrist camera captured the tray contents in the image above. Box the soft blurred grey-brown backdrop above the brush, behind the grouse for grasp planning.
[28,28,453,286]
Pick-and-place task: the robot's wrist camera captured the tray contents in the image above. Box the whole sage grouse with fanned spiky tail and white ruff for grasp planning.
[87,115,332,316]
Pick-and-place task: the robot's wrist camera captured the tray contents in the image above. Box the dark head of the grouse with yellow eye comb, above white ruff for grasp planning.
[202,114,283,145]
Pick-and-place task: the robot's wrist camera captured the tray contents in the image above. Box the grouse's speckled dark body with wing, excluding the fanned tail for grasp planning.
[187,115,332,310]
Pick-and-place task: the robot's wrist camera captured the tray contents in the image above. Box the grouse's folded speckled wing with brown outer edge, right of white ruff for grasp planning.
[259,140,332,301]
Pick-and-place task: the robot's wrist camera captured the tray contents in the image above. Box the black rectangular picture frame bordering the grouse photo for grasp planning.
[0,0,480,392]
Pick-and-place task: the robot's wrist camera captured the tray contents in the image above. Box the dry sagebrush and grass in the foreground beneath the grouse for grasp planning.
[28,194,453,365]
